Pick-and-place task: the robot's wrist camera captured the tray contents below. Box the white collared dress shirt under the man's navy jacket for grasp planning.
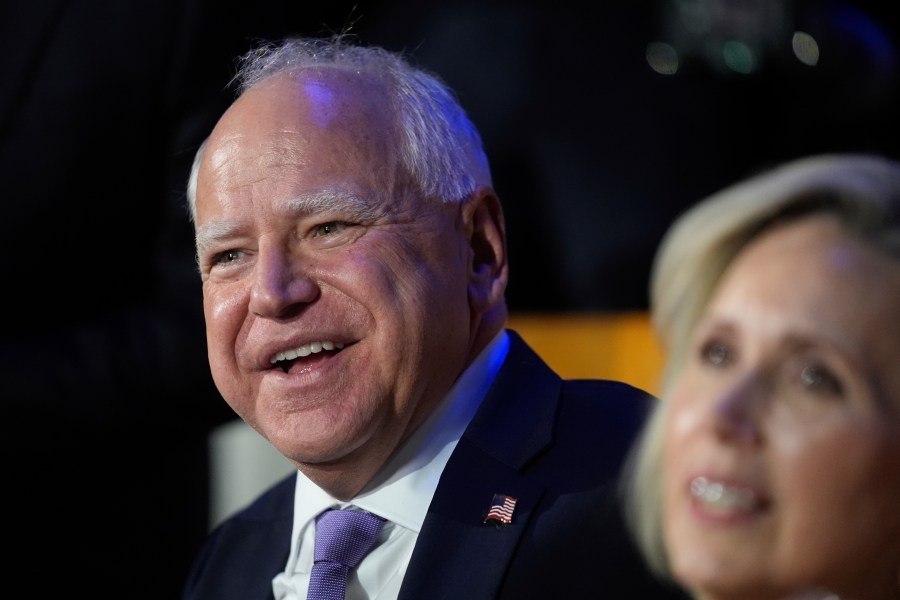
[272,331,509,600]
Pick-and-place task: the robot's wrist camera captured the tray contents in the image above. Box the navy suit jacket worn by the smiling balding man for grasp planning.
[184,331,684,600]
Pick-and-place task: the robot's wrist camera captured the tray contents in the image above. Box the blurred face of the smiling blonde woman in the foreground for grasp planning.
[663,216,900,600]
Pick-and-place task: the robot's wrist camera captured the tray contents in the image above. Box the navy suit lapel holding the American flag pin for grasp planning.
[399,332,561,600]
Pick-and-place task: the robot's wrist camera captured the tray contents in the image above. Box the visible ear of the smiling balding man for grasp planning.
[462,186,509,312]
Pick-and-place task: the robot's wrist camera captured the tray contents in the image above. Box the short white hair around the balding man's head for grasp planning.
[187,34,491,220]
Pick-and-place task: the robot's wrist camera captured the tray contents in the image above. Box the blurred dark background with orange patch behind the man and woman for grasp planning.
[0,0,900,600]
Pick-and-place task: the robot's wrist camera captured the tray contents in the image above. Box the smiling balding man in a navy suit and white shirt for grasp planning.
[185,36,688,600]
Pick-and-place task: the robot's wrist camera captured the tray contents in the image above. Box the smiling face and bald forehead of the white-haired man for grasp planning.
[197,74,473,493]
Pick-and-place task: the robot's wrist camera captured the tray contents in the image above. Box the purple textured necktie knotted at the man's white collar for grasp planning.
[306,510,384,600]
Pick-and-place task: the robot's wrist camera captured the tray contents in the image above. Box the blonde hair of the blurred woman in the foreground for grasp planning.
[622,154,900,577]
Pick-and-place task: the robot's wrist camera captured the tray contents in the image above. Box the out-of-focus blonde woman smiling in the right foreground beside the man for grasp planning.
[625,155,900,600]
